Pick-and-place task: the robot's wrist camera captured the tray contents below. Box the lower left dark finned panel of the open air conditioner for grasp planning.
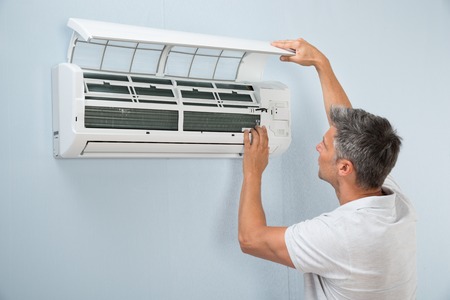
[84,106,178,130]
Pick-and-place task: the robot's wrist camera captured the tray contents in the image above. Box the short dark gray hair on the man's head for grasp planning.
[330,106,402,189]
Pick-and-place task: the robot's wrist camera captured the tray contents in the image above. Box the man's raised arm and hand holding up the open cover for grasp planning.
[272,39,352,124]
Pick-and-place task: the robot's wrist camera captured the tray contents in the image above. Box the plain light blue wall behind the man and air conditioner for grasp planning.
[0,0,450,300]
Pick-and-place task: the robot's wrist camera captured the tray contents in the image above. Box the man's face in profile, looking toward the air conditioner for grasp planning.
[316,126,338,186]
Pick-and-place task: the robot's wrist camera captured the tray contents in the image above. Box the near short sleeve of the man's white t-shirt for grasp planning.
[285,215,350,279]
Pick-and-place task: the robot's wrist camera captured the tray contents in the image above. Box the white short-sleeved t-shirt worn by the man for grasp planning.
[285,177,417,300]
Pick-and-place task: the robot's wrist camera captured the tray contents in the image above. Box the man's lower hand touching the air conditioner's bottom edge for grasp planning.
[243,126,269,178]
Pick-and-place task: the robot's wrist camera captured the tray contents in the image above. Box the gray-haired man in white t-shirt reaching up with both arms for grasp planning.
[239,39,417,300]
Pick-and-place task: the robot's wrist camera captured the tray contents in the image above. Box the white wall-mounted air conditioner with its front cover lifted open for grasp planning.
[52,19,291,158]
